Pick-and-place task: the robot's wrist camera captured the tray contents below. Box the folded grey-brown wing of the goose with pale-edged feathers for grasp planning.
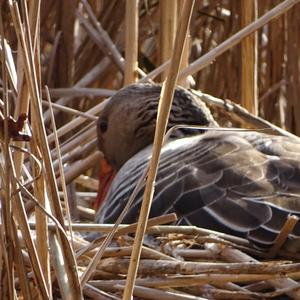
[98,132,300,244]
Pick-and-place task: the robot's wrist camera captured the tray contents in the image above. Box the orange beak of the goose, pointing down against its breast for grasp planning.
[94,158,116,211]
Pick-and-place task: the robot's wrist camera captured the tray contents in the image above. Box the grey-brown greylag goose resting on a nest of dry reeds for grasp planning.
[96,84,300,246]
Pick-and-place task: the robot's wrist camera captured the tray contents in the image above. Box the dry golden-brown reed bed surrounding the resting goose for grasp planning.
[0,0,300,299]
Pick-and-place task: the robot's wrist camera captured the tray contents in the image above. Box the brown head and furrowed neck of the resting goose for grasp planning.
[97,84,218,171]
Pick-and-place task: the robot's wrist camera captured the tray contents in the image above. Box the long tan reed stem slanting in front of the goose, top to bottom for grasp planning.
[123,1,194,300]
